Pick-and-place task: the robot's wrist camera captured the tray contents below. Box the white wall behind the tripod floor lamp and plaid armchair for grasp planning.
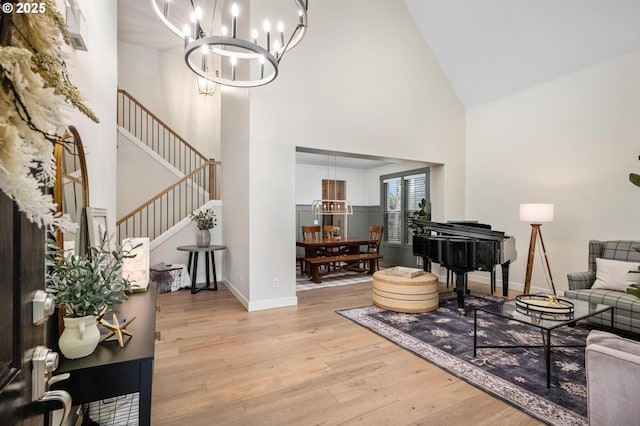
[466,52,640,291]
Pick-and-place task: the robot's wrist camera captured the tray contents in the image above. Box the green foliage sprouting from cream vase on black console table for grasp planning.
[45,233,138,318]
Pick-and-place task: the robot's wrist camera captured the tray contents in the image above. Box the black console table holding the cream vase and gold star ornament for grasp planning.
[45,283,156,425]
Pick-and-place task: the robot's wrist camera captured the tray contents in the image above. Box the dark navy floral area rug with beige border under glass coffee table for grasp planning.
[338,293,590,425]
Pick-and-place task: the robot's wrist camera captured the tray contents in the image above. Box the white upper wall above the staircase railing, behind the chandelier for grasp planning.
[118,41,221,159]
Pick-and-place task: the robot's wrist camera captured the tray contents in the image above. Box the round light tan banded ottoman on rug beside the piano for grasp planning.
[373,271,439,313]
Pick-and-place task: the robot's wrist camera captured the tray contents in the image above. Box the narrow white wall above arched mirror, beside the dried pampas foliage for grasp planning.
[56,0,118,233]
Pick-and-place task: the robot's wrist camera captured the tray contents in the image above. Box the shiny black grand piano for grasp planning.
[413,219,517,314]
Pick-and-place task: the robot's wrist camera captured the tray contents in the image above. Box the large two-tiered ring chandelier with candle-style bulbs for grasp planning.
[150,0,308,87]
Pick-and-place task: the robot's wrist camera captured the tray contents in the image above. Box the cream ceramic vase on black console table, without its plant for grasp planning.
[58,315,100,359]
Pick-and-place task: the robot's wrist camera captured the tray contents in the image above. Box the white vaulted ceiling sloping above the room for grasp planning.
[118,0,640,108]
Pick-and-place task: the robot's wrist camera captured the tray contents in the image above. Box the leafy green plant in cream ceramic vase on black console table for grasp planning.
[46,234,135,359]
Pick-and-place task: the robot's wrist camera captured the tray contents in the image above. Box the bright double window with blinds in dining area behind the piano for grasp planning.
[380,168,431,245]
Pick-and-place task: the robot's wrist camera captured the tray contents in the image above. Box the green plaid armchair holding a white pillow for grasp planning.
[564,240,640,333]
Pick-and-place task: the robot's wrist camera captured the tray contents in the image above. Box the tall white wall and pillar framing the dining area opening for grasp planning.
[222,0,465,310]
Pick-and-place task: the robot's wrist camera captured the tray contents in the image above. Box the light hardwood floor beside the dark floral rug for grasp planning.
[151,282,541,425]
